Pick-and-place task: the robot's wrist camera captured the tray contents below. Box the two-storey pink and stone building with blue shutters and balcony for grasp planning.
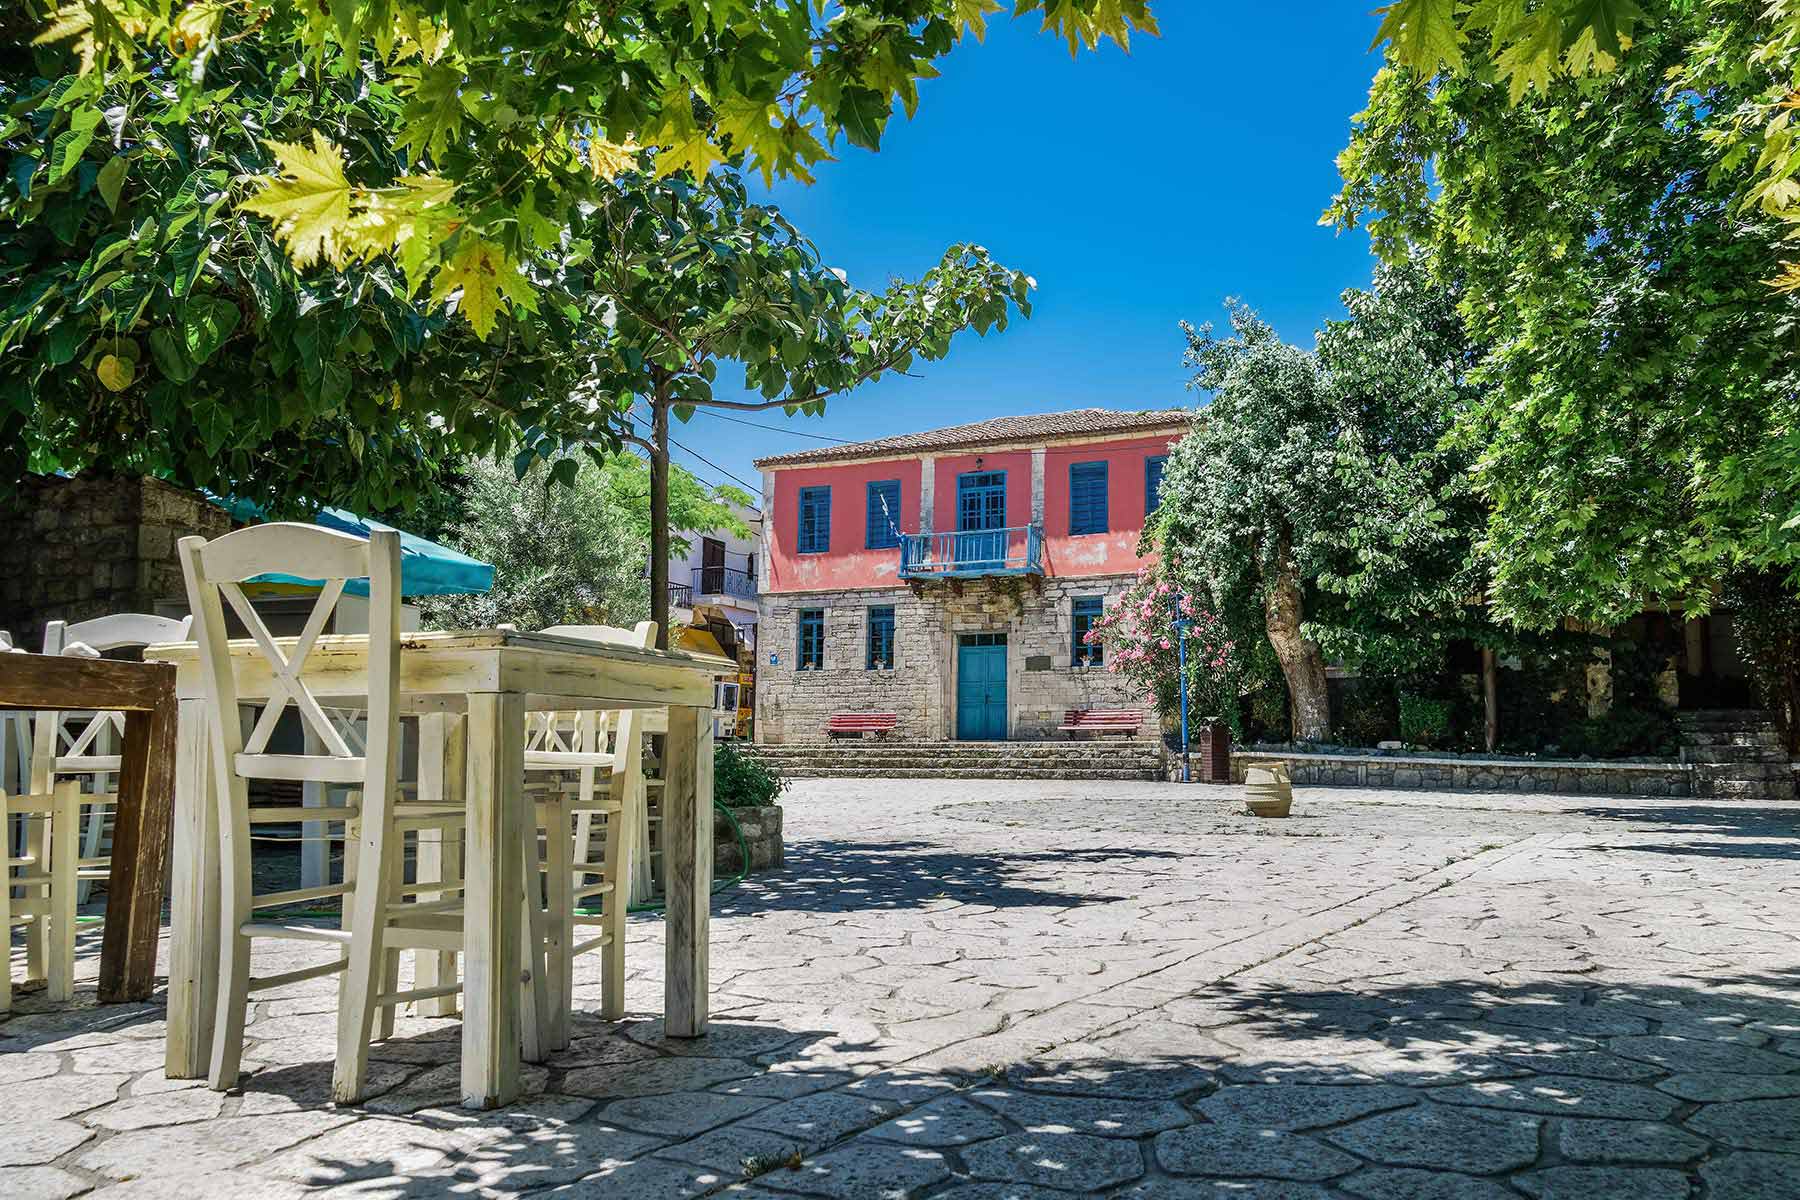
[756,408,1192,743]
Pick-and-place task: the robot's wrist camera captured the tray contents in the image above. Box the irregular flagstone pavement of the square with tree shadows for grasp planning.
[0,779,1800,1200]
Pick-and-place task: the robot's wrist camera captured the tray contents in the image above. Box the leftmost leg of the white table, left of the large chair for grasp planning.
[166,700,220,1079]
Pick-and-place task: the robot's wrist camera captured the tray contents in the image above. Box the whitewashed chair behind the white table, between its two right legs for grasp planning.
[526,621,657,1049]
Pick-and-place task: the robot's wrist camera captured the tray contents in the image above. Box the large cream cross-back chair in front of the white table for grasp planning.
[180,524,544,1103]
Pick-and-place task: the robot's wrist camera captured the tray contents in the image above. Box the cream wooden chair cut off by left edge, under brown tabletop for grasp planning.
[0,779,81,1013]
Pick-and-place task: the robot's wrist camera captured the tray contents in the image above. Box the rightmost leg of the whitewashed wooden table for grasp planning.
[662,705,713,1038]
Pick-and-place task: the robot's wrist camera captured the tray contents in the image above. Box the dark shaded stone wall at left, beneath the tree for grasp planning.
[0,475,232,649]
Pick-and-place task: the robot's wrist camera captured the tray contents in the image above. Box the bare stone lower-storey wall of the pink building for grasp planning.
[756,576,1157,745]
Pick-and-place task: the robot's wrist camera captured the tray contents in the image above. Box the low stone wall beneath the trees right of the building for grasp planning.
[1231,750,1694,795]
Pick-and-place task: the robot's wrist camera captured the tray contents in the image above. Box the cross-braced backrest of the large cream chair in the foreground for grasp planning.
[178,524,400,797]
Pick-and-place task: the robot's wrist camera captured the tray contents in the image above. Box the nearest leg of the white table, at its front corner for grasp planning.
[463,693,527,1108]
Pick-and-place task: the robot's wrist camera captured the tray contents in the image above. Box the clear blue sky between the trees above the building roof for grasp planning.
[673,0,1379,482]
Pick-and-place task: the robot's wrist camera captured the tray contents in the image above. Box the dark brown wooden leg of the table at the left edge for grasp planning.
[99,689,176,1004]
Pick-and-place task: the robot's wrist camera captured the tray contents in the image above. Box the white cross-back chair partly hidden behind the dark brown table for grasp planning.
[31,612,193,905]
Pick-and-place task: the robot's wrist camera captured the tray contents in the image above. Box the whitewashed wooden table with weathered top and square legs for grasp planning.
[144,630,734,1108]
